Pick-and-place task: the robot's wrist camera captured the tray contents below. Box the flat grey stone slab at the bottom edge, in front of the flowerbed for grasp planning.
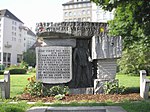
[27,106,127,112]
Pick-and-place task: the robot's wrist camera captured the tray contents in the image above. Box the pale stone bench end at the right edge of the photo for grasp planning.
[140,70,150,99]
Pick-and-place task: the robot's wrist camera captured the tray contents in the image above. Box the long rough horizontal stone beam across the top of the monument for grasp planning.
[36,22,107,38]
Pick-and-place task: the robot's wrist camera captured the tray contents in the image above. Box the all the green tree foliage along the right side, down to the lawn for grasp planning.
[91,0,150,73]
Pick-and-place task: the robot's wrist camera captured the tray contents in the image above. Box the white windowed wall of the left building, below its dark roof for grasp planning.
[1,17,25,64]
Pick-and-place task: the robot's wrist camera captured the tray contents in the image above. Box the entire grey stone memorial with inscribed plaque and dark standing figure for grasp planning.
[36,22,122,93]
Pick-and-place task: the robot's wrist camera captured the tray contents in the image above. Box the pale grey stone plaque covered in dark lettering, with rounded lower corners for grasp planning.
[36,46,72,84]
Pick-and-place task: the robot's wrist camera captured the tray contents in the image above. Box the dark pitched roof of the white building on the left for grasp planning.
[0,9,23,23]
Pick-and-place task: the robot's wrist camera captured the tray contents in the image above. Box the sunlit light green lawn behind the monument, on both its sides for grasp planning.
[0,73,150,97]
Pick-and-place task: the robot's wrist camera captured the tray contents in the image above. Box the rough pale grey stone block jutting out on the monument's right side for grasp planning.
[92,34,122,59]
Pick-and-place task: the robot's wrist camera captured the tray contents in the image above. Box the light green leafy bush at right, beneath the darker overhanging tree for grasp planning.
[118,45,150,75]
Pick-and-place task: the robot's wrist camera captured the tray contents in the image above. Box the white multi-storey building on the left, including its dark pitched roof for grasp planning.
[0,9,36,66]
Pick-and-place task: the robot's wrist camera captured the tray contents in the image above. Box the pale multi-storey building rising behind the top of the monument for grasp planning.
[62,0,113,22]
